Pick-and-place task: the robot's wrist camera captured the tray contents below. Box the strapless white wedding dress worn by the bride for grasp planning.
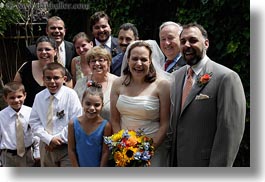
[116,95,168,167]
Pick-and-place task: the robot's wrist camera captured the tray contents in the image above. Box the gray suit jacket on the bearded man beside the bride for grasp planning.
[168,57,246,167]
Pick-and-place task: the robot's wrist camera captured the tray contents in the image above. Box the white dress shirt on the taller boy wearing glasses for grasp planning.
[29,86,82,145]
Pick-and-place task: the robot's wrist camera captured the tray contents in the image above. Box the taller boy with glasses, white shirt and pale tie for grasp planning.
[29,62,82,167]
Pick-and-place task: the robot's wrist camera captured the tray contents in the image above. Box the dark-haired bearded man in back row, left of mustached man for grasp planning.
[90,11,121,57]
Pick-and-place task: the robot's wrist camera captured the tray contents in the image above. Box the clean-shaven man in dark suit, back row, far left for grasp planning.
[26,16,76,72]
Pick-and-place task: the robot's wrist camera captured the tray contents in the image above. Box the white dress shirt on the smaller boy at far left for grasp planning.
[0,105,40,158]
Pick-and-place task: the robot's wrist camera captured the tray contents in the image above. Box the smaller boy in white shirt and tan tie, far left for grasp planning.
[0,81,40,167]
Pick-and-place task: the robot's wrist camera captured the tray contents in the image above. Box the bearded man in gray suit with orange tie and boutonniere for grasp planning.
[168,23,246,167]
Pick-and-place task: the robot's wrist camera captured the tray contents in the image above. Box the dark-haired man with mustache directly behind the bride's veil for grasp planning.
[110,23,139,76]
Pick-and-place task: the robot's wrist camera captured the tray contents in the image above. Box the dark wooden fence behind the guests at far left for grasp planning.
[0,23,46,84]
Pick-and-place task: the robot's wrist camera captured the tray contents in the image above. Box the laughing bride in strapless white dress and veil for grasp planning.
[110,40,170,167]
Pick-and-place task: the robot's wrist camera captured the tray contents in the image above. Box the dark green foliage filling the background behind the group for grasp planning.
[0,0,250,166]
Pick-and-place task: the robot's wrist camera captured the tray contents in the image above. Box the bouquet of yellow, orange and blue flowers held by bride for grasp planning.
[104,129,154,167]
